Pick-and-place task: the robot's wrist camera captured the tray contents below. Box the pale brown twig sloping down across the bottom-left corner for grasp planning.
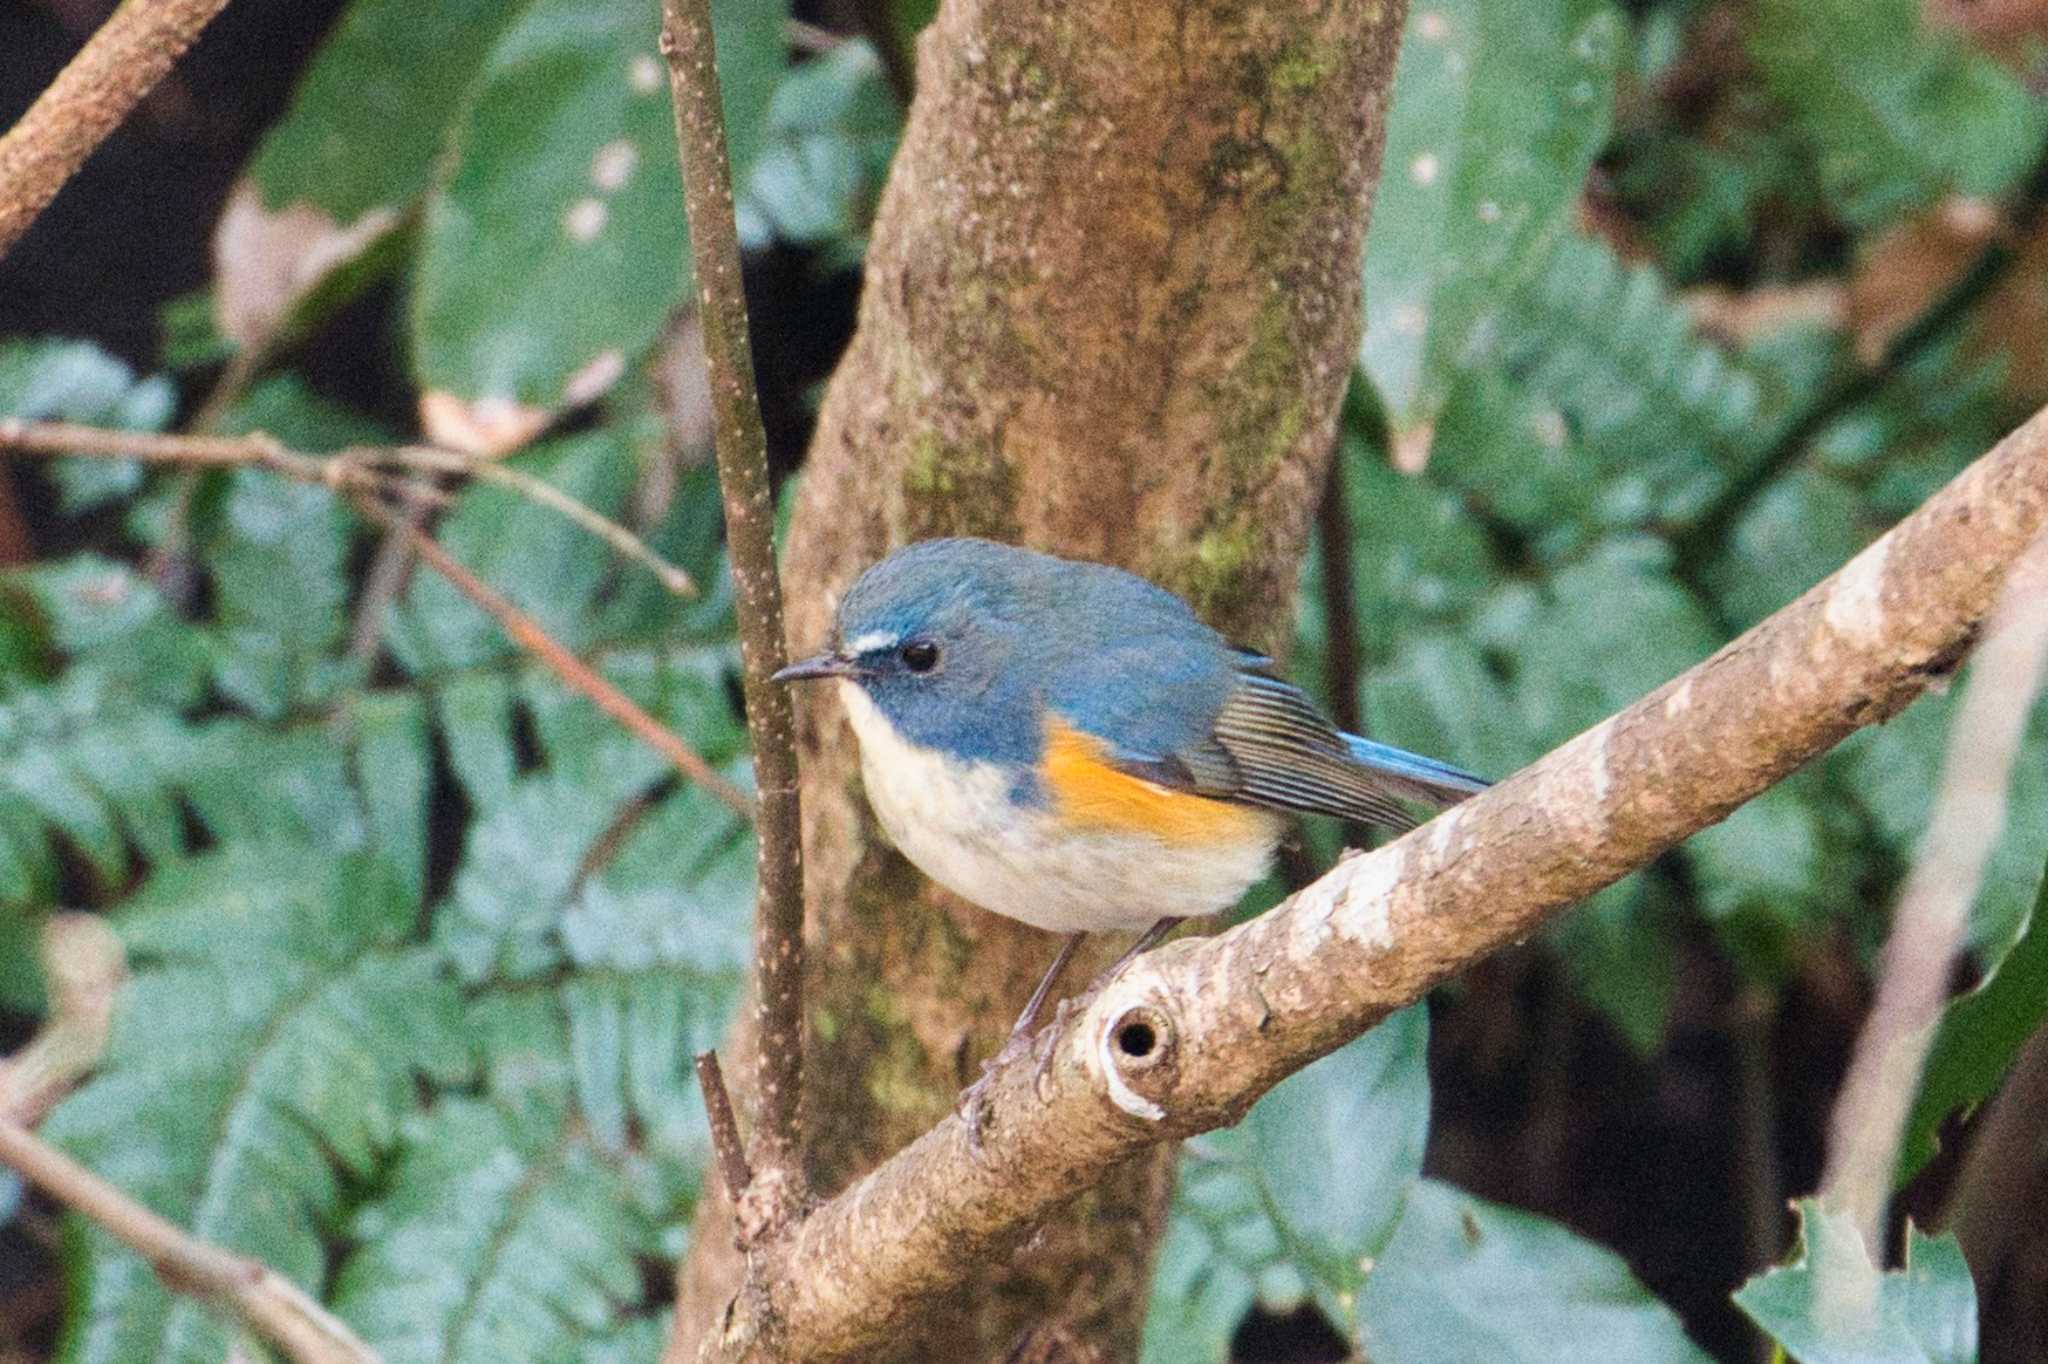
[0,1116,379,1364]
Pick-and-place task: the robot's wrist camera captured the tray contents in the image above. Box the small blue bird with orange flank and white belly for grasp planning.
[774,537,1487,1137]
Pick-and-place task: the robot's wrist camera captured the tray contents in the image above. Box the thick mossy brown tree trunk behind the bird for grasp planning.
[680,0,1405,1364]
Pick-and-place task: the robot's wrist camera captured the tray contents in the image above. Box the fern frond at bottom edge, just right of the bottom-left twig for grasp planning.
[334,1098,655,1364]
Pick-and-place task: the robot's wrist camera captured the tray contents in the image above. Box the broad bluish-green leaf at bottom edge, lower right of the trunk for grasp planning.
[1358,1180,1708,1364]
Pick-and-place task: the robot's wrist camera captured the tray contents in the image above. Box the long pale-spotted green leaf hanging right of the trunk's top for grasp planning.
[1362,0,1622,449]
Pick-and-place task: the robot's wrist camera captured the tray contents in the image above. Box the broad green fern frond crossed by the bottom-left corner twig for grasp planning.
[45,842,469,1364]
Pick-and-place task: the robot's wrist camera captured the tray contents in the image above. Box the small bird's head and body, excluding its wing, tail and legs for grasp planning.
[780,539,1278,932]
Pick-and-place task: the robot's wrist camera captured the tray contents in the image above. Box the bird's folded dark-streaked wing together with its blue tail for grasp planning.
[1118,653,1487,829]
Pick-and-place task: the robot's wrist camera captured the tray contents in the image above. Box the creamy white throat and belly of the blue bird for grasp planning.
[840,680,1280,934]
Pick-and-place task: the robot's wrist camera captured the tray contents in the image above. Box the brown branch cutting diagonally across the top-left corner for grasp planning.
[0,0,227,256]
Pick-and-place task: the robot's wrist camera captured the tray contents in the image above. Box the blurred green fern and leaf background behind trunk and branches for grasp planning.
[0,0,2048,1364]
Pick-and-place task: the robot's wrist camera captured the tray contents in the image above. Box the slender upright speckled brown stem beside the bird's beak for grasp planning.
[662,0,807,1225]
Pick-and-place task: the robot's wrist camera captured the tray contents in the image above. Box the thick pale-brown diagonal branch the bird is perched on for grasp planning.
[700,412,2048,1360]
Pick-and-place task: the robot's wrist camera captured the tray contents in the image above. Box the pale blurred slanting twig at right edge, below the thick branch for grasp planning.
[1821,537,2048,1264]
